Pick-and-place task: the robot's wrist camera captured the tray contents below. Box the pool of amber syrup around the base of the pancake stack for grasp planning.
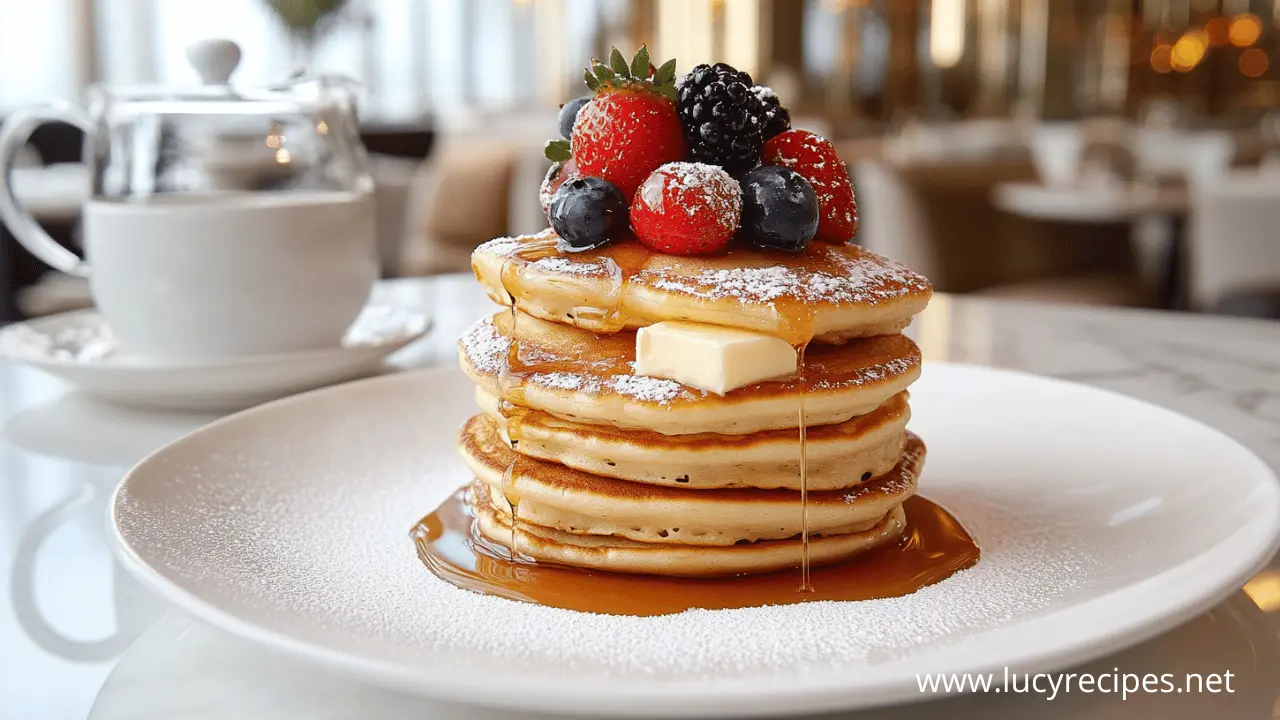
[411,491,980,616]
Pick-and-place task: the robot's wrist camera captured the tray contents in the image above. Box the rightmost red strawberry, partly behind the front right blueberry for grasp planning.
[764,129,858,242]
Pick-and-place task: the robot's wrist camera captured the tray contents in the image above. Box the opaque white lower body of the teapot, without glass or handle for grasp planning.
[84,192,378,360]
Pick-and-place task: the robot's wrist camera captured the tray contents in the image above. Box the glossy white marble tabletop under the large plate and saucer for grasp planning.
[0,275,1280,720]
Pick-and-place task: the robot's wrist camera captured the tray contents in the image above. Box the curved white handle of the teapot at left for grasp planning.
[0,102,93,278]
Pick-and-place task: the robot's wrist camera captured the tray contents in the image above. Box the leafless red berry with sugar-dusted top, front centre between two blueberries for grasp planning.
[631,163,742,255]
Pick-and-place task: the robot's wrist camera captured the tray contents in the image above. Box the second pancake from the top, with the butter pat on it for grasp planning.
[458,311,920,436]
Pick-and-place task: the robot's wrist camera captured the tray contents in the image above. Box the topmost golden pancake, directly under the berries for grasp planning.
[471,229,933,345]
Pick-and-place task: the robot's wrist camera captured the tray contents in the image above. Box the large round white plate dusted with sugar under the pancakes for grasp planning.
[111,364,1280,716]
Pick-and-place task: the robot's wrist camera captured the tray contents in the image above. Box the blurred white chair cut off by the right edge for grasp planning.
[1187,172,1280,310]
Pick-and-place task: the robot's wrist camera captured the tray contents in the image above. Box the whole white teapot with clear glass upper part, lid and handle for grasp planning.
[0,51,378,361]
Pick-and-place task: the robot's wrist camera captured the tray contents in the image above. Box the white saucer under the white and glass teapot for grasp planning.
[0,305,431,410]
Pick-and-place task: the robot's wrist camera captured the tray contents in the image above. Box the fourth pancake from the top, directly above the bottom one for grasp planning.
[458,415,924,546]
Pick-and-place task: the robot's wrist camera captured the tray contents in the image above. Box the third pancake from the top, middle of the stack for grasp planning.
[476,388,911,489]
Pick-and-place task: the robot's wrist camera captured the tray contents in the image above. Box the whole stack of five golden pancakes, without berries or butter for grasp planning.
[460,233,931,577]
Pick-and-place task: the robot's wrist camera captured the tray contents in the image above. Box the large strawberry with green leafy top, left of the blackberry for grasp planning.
[570,47,686,199]
